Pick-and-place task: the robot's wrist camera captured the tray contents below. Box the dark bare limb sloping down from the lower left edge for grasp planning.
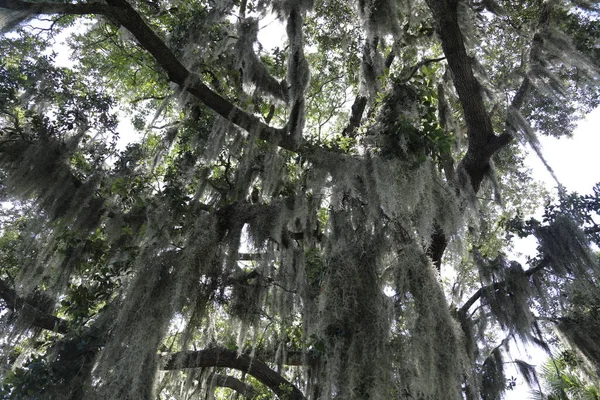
[0,279,69,334]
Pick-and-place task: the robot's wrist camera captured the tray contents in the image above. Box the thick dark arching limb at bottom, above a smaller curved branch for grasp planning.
[163,347,305,400]
